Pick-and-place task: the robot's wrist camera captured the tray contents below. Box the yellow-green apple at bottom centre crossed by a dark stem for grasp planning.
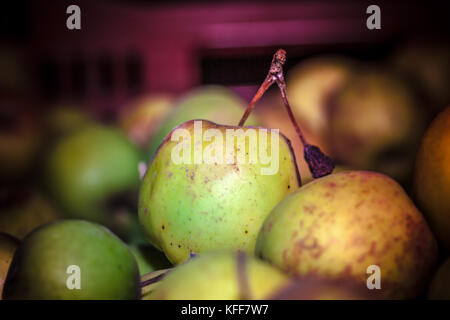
[146,252,289,300]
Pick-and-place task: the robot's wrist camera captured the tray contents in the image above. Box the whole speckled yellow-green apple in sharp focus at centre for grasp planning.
[139,120,300,264]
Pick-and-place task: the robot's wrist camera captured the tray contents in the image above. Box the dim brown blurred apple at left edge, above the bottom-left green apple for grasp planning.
[0,187,61,239]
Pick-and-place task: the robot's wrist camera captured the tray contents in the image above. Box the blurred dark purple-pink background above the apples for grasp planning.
[3,0,449,114]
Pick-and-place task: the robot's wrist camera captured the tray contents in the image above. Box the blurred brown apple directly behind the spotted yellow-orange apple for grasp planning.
[328,68,425,184]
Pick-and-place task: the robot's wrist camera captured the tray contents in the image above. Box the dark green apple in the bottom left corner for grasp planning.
[3,220,140,300]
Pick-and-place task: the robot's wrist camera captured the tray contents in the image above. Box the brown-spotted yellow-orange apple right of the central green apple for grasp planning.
[256,171,438,299]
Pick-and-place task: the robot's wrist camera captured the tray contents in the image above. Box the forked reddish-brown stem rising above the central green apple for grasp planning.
[239,49,334,178]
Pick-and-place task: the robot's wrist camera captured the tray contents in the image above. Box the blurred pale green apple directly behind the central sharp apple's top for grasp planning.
[146,86,259,159]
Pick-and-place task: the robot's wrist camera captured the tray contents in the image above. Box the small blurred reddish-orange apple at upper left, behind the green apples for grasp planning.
[119,94,174,148]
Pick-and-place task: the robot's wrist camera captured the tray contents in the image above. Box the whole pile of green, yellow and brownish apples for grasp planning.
[0,45,450,300]
